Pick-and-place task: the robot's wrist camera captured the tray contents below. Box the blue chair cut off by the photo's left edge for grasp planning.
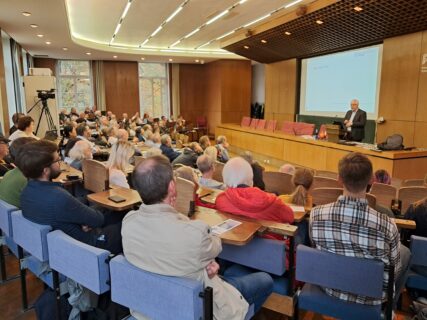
[0,200,18,281]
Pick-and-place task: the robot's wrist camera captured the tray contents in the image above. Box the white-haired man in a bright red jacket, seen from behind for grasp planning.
[215,157,294,223]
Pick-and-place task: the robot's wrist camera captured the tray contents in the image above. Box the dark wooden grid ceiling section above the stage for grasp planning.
[224,0,427,63]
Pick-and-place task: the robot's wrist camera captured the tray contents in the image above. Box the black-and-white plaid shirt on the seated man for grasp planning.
[309,196,401,305]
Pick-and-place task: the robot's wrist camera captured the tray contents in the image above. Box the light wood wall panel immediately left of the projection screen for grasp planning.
[264,59,298,123]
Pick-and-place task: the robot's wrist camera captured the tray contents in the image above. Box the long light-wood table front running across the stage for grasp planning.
[215,124,427,180]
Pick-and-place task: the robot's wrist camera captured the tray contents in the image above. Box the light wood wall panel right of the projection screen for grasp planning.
[376,31,427,147]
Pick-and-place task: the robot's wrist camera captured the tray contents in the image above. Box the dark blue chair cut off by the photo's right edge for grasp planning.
[406,236,427,291]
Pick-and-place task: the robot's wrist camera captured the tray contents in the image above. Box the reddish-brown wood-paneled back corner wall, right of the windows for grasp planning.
[179,60,251,133]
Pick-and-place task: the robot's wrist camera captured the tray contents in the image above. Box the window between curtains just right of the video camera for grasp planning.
[57,60,93,112]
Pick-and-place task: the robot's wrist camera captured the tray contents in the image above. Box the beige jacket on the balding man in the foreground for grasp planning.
[122,204,249,320]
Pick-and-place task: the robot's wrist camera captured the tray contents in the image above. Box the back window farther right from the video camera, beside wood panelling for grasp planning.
[139,63,170,118]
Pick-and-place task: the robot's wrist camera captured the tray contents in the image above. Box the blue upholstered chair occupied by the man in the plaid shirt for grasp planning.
[295,245,394,320]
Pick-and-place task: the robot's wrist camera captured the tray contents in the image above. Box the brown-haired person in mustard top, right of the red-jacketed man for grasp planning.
[279,168,313,209]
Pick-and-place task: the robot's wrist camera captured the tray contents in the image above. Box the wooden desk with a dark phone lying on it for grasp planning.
[87,187,142,211]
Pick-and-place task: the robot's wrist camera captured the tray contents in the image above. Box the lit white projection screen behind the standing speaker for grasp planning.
[300,45,382,119]
